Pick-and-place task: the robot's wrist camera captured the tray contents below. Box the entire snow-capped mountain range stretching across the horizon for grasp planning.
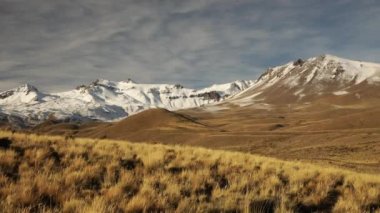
[0,55,380,128]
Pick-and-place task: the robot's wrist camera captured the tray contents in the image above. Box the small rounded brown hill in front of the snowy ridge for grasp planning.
[78,109,214,142]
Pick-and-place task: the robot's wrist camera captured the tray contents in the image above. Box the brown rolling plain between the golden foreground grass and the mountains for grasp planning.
[31,105,380,174]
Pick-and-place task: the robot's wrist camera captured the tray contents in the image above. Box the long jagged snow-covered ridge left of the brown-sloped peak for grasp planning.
[0,80,253,125]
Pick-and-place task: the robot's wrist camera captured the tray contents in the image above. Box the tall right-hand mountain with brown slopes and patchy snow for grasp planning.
[229,55,380,103]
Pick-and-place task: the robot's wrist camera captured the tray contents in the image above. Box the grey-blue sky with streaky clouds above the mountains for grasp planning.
[0,0,380,92]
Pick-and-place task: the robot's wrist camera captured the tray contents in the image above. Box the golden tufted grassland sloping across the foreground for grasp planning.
[0,132,380,212]
